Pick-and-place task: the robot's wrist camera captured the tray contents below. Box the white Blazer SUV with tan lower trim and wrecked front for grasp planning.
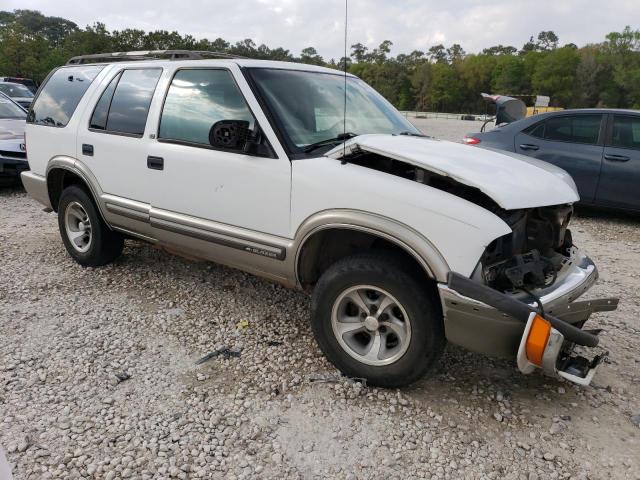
[22,51,617,386]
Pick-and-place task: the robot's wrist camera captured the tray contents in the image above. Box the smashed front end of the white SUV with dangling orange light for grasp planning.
[440,205,618,385]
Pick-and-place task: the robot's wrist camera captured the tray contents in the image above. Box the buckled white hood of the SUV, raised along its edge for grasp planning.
[326,135,580,210]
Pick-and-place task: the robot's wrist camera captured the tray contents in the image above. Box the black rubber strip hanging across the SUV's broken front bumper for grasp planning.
[448,272,599,347]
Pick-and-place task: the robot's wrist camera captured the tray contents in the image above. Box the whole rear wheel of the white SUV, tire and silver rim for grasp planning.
[58,185,124,267]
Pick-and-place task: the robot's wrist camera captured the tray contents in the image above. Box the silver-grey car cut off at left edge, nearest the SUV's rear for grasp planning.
[0,93,29,185]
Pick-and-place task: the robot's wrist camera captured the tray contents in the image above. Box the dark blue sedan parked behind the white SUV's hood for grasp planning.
[464,109,640,211]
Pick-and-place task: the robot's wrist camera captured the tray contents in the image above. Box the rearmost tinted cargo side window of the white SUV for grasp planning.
[27,65,104,127]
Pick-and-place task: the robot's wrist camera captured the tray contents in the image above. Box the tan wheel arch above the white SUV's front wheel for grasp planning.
[293,209,450,288]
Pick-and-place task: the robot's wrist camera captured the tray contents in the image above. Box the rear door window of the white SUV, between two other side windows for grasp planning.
[89,68,162,136]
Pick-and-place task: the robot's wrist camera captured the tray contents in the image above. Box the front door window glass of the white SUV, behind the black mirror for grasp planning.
[158,68,255,146]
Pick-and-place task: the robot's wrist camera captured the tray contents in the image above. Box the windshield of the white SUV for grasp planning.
[250,68,420,152]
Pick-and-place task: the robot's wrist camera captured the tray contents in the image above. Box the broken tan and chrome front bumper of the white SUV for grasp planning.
[438,248,618,358]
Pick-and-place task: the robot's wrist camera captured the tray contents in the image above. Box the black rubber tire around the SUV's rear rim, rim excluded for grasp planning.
[58,185,124,267]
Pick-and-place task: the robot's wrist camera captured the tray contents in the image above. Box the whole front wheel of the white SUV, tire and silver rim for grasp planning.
[312,253,445,387]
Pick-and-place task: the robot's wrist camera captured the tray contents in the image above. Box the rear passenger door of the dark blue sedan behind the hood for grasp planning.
[514,113,606,203]
